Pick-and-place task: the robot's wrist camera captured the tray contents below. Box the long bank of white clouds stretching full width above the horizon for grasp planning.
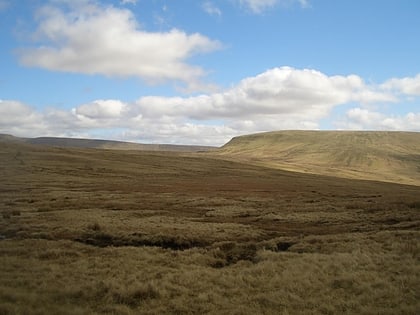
[0,67,420,145]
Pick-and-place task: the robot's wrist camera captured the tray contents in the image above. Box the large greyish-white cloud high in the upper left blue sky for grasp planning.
[19,0,221,89]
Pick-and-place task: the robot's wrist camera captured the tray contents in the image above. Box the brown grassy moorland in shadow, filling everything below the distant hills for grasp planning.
[0,143,420,314]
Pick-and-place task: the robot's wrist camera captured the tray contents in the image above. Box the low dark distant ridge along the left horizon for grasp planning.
[0,134,214,152]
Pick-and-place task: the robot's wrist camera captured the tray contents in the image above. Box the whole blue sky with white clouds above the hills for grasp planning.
[0,0,420,146]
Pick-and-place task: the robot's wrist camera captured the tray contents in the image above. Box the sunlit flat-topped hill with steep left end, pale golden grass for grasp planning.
[218,131,420,185]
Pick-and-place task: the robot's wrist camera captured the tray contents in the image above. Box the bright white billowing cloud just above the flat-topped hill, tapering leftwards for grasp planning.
[137,67,395,120]
